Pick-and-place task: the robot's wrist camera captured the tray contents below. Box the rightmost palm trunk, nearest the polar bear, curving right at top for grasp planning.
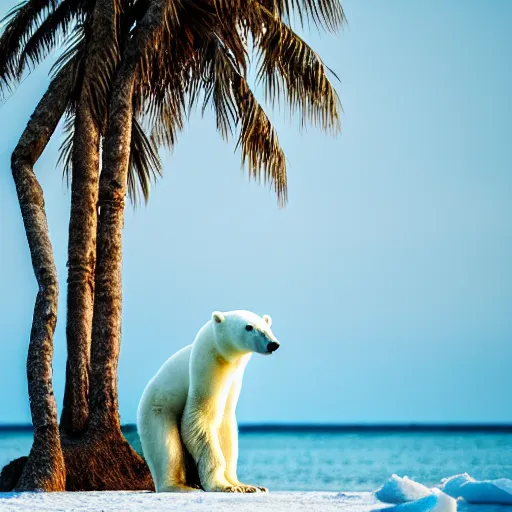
[91,0,166,431]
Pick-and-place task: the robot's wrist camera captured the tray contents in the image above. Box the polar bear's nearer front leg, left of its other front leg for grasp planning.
[181,403,243,492]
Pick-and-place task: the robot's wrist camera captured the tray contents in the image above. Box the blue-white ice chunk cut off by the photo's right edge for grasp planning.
[441,473,512,505]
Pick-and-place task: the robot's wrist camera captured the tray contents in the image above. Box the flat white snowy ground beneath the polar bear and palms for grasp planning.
[0,492,512,512]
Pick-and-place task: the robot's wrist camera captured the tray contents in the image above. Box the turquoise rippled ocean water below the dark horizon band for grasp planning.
[0,431,512,491]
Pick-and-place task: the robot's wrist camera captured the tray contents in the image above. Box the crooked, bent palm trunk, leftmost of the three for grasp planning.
[11,71,68,491]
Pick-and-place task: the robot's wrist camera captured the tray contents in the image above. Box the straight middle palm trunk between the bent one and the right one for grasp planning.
[61,0,117,438]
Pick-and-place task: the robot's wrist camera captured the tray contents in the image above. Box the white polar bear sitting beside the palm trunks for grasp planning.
[137,311,279,492]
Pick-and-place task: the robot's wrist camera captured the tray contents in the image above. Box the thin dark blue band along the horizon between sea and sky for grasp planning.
[0,422,512,433]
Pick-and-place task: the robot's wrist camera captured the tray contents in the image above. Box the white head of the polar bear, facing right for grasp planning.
[212,311,279,355]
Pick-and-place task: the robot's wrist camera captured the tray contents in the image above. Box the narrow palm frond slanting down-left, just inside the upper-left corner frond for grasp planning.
[17,0,88,76]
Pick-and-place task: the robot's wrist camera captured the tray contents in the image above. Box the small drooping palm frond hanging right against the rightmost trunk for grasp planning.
[128,118,162,206]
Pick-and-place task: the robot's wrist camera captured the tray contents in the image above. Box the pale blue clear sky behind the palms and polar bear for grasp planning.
[0,0,512,423]
